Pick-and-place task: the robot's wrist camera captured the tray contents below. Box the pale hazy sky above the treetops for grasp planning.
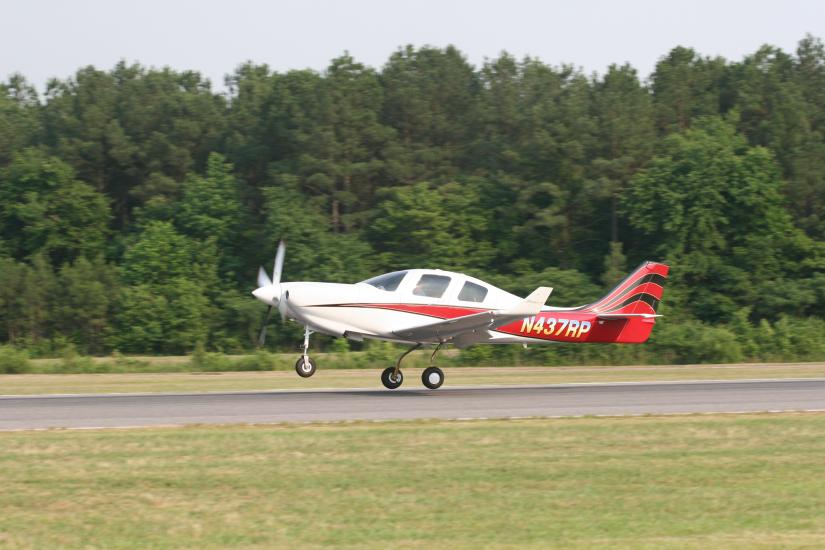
[0,0,825,89]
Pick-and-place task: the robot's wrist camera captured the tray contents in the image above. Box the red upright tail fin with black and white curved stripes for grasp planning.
[583,262,670,315]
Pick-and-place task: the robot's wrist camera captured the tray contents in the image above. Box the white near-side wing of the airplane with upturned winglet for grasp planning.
[393,286,553,342]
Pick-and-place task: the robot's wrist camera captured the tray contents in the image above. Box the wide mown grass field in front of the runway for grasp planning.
[0,414,825,549]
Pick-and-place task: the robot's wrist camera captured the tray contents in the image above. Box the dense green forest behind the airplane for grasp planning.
[0,36,825,361]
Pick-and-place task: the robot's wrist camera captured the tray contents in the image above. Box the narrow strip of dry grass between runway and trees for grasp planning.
[0,363,825,395]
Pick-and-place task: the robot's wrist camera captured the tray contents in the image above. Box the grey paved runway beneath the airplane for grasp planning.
[0,379,825,430]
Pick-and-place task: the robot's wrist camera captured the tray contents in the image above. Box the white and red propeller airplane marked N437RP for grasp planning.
[252,241,669,390]
